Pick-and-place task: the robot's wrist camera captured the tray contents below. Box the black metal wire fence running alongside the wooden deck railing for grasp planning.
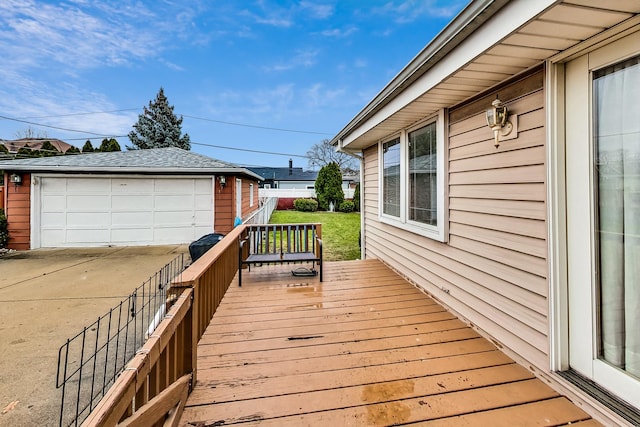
[56,254,185,426]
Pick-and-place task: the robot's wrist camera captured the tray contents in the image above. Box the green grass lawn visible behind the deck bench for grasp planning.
[270,211,360,261]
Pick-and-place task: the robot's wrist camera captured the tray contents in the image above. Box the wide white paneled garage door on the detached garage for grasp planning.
[33,177,213,247]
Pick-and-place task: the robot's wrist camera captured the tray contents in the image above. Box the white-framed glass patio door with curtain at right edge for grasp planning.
[565,33,640,406]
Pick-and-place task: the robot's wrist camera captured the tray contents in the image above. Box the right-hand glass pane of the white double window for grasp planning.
[409,123,438,225]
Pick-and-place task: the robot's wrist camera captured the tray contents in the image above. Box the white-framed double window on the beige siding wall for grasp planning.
[379,110,445,241]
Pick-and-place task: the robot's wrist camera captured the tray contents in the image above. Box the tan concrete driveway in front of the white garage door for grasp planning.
[0,245,189,426]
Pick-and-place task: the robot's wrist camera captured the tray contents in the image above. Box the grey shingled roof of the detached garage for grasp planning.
[0,147,262,180]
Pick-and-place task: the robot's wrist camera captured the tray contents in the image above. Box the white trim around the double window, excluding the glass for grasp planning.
[378,109,448,242]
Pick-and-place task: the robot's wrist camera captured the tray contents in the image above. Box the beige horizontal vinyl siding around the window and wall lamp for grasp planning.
[364,70,549,370]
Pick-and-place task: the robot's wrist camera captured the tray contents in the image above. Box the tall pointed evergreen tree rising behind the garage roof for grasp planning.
[127,87,191,150]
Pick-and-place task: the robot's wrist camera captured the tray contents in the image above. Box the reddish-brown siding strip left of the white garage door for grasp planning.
[4,173,31,250]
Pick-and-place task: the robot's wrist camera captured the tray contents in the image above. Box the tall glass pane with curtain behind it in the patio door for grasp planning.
[593,53,640,377]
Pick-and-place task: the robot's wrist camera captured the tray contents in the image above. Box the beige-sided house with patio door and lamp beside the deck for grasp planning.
[331,0,640,425]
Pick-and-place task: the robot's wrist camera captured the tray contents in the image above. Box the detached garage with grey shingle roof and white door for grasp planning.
[0,148,260,249]
